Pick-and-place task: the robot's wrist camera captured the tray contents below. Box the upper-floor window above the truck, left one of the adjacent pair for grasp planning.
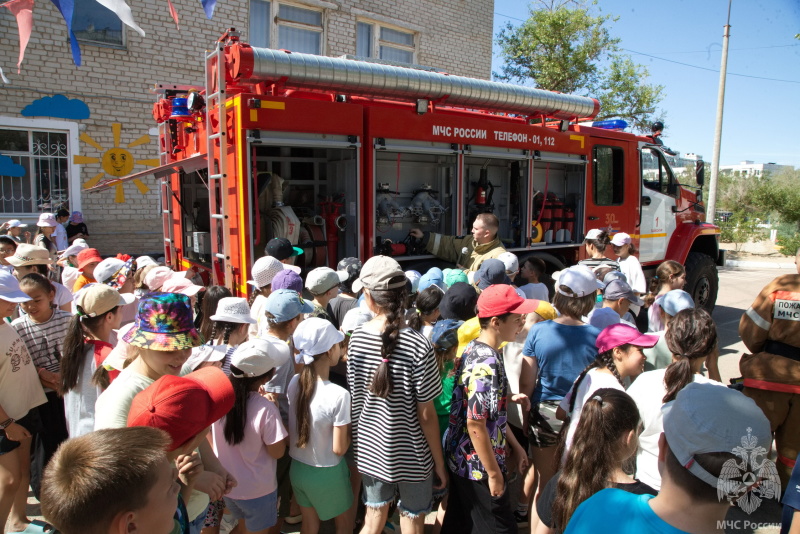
[250,0,325,54]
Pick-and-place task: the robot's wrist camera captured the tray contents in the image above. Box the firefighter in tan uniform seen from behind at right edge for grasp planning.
[739,250,800,487]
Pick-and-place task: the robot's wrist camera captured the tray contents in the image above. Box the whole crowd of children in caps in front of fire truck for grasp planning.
[0,219,792,534]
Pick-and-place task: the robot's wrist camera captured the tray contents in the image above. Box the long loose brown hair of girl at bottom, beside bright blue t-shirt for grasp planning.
[552,388,640,531]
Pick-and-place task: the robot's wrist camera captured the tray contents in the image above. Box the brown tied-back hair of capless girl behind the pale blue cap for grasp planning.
[663,308,717,402]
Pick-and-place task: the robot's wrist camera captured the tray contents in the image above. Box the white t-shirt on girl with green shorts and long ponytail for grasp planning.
[287,375,350,467]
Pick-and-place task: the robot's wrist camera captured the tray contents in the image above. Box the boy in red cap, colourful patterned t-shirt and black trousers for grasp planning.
[442,284,536,534]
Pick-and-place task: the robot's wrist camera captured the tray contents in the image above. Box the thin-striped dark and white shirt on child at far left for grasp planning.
[11,309,72,373]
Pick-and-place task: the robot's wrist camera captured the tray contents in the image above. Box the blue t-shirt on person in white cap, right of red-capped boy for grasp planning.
[522,321,600,403]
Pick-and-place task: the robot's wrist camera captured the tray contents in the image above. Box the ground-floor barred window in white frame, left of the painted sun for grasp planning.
[0,128,70,214]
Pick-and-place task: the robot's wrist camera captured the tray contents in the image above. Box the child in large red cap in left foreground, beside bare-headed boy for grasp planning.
[128,367,234,534]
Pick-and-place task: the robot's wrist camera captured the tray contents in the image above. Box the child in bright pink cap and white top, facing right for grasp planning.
[556,323,658,459]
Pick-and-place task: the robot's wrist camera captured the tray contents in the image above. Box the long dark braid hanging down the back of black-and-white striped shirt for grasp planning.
[369,282,408,399]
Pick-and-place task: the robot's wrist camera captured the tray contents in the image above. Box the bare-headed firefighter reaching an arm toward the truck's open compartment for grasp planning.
[409,213,506,272]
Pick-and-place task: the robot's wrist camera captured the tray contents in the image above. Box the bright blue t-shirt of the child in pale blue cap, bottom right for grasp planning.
[564,488,686,534]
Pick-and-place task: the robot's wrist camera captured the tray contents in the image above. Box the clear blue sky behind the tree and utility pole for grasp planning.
[492,0,800,167]
